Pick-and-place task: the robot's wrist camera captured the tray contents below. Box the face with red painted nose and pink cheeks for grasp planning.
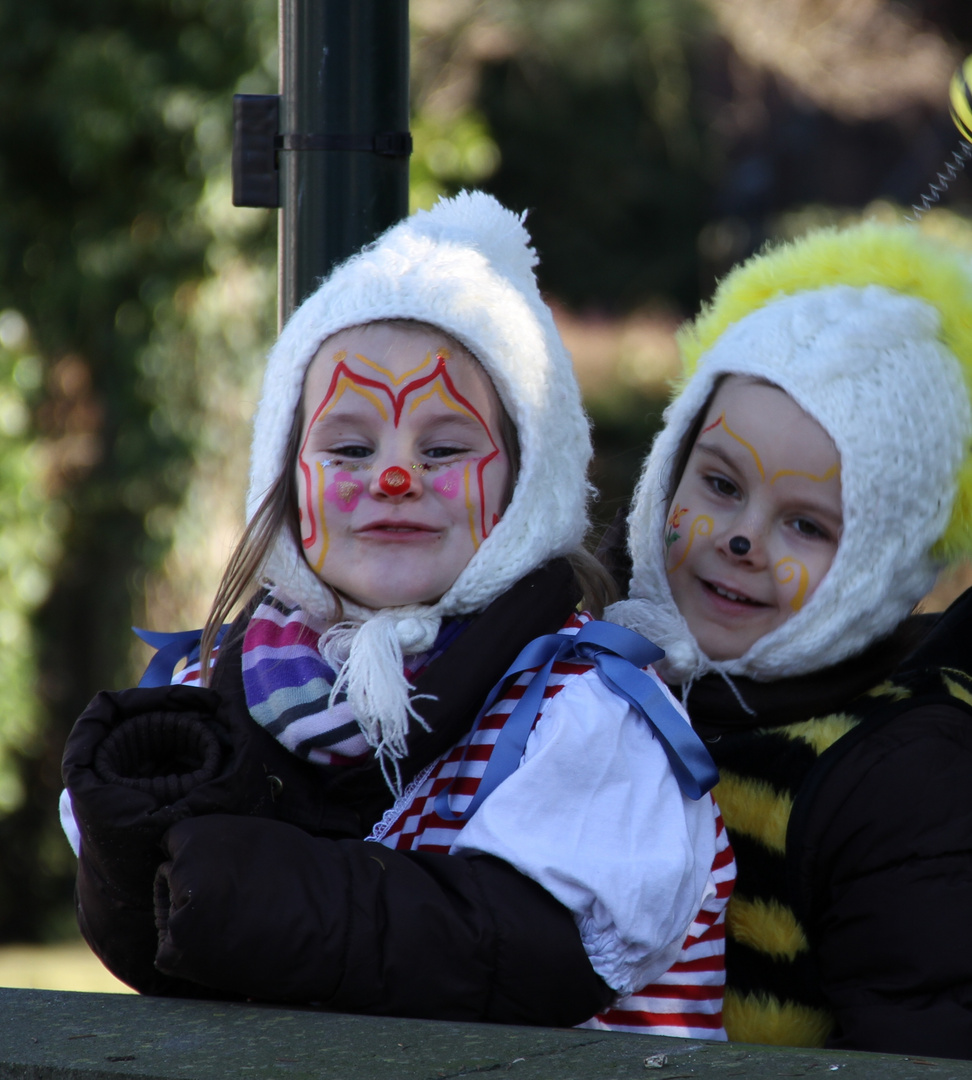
[296,323,510,607]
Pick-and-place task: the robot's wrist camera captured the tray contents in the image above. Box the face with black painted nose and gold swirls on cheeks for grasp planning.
[663,377,843,660]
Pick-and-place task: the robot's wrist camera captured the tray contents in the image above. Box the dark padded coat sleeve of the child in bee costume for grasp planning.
[805,704,972,1057]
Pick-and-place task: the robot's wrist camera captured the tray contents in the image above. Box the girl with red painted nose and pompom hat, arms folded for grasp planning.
[63,194,733,1038]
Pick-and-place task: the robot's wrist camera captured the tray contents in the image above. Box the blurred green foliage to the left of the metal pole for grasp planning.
[0,0,276,941]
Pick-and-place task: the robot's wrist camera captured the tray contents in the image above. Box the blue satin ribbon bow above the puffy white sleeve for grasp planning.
[435,620,719,821]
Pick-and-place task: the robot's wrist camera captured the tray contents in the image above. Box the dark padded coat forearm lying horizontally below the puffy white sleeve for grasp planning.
[157,814,612,1026]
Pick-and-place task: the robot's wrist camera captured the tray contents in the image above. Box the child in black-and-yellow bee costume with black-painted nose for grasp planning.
[607,224,972,1057]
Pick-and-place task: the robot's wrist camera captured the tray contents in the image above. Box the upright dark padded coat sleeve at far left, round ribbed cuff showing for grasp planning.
[62,687,336,995]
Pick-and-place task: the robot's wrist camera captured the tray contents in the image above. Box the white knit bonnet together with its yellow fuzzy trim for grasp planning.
[607,222,972,684]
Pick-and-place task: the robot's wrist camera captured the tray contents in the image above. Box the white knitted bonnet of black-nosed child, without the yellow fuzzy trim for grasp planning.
[607,285,972,683]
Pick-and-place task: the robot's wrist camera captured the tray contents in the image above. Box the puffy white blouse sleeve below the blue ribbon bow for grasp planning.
[451,670,716,995]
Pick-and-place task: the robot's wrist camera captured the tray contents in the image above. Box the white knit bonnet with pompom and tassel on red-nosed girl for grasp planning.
[246,192,592,756]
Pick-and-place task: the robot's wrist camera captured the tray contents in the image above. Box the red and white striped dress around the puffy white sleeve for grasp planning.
[369,616,735,1039]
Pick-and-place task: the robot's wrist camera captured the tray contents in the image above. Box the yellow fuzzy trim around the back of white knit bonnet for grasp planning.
[678,221,972,561]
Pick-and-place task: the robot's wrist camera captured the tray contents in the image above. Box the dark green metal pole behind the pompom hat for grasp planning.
[278,0,410,326]
